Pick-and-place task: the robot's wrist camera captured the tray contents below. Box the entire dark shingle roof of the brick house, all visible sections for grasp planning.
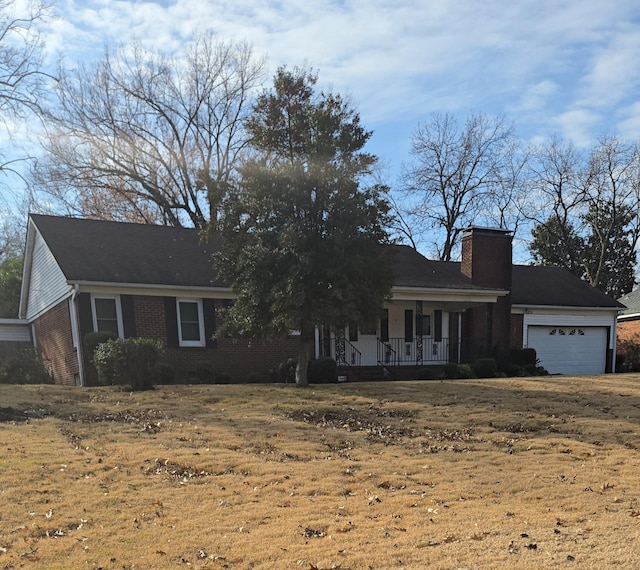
[31,214,623,308]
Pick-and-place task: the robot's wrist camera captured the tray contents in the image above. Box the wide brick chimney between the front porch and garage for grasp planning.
[460,227,512,355]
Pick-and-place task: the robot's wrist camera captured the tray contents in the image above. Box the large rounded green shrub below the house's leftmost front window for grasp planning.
[93,338,162,390]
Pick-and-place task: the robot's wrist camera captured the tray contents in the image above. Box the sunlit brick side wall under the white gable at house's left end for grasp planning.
[33,299,78,385]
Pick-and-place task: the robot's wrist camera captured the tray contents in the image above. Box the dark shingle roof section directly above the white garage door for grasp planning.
[511,265,623,308]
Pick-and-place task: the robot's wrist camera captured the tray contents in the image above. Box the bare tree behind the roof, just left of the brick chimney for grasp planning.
[402,113,521,261]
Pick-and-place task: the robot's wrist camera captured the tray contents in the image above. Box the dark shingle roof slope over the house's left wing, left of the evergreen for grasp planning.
[31,215,225,287]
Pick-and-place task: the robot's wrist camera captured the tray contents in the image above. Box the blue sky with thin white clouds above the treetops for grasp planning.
[3,0,640,253]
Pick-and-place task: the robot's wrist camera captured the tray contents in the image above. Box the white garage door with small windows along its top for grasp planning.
[528,325,607,374]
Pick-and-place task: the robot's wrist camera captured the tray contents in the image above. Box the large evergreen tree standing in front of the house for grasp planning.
[216,68,393,385]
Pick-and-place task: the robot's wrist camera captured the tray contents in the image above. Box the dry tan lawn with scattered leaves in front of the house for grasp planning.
[0,375,640,570]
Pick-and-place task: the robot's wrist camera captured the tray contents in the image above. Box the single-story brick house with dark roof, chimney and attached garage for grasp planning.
[19,215,622,385]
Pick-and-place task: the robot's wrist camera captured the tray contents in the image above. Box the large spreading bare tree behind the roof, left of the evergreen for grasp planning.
[33,33,263,228]
